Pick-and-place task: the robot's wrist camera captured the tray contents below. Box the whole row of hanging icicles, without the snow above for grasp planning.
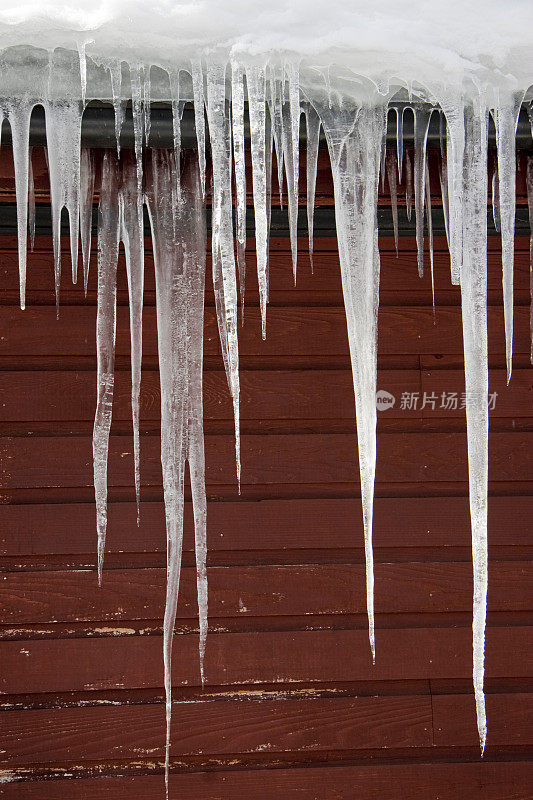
[7,62,533,790]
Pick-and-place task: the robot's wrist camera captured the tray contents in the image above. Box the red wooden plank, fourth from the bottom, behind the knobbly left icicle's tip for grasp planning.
[0,562,533,625]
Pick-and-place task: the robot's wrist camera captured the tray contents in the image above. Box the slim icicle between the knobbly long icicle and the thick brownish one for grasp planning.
[119,152,144,525]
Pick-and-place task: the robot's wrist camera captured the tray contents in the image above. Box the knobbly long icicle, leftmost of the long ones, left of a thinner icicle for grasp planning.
[93,151,120,584]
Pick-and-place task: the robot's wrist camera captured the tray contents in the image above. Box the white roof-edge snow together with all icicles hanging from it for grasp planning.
[0,0,533,786]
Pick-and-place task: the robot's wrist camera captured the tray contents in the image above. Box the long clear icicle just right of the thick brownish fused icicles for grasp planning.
[207,64,241,487]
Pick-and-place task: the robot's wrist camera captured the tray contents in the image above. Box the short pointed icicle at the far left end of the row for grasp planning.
[0,99,34,309]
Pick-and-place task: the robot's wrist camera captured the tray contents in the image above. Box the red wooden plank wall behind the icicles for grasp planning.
[0,152,533,800]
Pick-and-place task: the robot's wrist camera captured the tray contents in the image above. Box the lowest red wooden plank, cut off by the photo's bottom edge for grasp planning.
[0,761,532,800]
